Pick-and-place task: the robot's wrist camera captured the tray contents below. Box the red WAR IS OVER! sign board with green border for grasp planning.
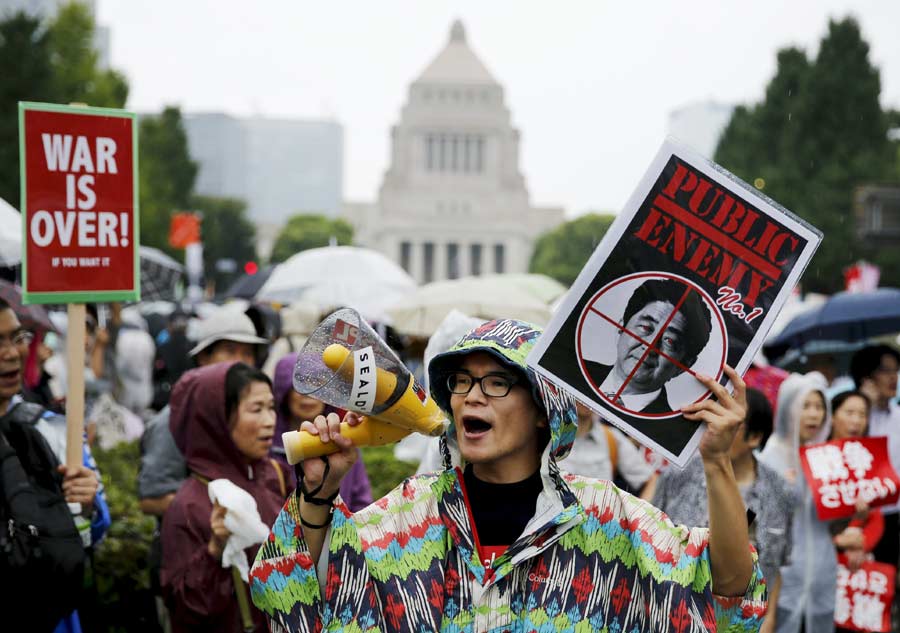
[19,103,140,303]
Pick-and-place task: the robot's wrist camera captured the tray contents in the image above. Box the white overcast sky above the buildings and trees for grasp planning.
[97,0,900,216]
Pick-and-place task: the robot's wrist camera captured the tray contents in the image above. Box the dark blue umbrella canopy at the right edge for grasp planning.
[764,288,900,358]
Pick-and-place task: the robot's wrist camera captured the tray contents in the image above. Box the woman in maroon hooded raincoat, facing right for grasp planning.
[160,363,284,633]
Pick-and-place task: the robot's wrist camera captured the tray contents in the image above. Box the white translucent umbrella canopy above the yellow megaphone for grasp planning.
[256,246,416,323]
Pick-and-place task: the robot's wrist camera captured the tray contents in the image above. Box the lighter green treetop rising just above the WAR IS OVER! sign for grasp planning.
[48,2,128,108]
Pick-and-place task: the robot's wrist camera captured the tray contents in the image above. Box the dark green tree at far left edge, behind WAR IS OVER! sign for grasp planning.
[0,12,56,208]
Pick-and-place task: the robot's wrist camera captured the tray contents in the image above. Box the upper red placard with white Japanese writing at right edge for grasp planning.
[800,437,900,521]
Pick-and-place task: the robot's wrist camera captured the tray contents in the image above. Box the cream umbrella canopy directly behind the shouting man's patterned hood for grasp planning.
[389,275,550,336]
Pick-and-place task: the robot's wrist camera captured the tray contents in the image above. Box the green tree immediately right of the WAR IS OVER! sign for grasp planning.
[138,107,197,254]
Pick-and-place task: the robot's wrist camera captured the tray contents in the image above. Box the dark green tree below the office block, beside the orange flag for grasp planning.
[191,196,256,292]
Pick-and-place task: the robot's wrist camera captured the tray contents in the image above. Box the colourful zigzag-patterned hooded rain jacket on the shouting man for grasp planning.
[251,321,766,633]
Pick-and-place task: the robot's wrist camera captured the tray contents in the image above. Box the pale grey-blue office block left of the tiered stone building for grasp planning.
[184,112,344,258]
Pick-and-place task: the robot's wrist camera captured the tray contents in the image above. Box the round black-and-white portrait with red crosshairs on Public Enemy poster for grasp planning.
[582,277,719,415]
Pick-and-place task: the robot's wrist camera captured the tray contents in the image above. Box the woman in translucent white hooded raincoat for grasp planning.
[759,372,837,633]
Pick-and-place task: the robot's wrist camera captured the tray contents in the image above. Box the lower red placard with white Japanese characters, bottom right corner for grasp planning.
[834,554,897,633]
